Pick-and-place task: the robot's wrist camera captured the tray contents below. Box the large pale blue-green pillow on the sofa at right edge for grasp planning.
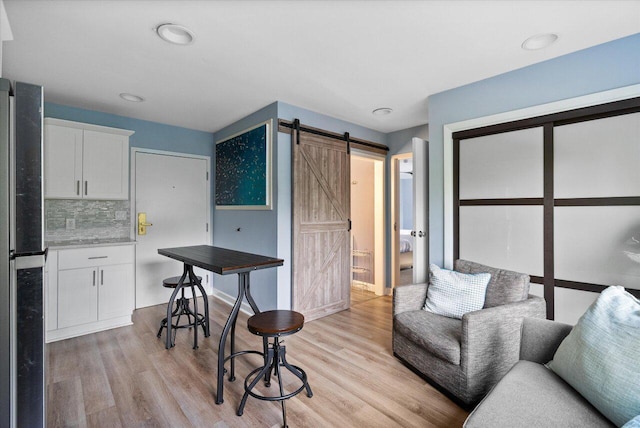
[547,286,640,427]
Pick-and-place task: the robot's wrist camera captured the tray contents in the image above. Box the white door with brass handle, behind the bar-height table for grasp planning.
[132,151,211,308]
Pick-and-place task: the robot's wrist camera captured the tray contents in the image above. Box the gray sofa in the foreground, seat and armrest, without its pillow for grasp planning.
[464,319,614,428]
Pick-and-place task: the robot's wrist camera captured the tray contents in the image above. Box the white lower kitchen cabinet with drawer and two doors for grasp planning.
[47,245,134,342]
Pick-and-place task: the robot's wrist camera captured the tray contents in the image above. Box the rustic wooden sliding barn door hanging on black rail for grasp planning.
[292,132,351,320]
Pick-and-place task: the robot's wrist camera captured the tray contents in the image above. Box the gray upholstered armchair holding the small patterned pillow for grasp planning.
[393,260,546,407]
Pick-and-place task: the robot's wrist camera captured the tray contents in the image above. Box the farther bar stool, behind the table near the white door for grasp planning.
[157,276,208,349]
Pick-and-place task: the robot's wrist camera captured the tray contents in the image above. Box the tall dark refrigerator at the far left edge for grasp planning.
[0,79,46,428]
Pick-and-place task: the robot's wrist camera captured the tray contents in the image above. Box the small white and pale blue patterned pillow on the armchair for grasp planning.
[423,264,491,319]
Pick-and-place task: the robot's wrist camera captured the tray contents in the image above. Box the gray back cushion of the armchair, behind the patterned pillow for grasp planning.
[454,260,530,308]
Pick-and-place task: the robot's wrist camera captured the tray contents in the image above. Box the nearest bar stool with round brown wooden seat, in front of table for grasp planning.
[238,310,313,428]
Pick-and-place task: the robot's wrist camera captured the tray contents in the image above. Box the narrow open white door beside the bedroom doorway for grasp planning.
[411,138,429,284]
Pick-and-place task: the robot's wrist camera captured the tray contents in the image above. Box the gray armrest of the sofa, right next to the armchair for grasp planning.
[520,318,573,364]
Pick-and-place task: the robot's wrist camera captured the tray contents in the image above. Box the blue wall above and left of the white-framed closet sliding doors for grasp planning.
[428,33,640,265]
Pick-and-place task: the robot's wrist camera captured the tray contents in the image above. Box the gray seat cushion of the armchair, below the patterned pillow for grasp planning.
[394,310,462,365]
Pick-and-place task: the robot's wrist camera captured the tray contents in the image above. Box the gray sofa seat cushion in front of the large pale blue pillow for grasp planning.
[464,361,613,428]
